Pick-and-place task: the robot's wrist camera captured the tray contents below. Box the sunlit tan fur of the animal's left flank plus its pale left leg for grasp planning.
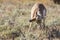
[29,3,40,31]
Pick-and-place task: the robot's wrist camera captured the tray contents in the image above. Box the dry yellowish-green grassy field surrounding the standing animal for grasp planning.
[0,0,60,40]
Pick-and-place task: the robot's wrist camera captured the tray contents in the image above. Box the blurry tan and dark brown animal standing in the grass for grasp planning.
[29,3,46,30]
